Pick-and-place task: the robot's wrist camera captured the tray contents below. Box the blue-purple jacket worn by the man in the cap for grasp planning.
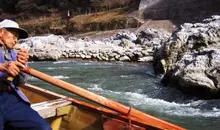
[0,46,29,103]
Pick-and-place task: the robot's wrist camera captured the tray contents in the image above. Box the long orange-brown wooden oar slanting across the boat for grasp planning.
[22,67,185,130]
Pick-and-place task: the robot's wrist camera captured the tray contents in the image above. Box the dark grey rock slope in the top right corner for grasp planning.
[139,0,220,25]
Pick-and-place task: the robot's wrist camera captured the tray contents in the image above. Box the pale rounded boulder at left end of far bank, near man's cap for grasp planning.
[20,35,66,60]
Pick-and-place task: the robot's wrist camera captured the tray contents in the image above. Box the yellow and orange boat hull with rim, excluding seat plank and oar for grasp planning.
[21,84,160,130]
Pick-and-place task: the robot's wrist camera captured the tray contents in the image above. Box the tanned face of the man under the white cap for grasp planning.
[0,29,19,49]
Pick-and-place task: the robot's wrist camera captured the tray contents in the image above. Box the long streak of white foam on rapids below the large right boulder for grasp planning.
[88,84,220,117]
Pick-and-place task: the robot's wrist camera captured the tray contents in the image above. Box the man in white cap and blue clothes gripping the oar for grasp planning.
[0,19,52,130]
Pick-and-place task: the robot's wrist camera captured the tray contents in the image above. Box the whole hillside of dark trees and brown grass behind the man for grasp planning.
[0,0,139,35]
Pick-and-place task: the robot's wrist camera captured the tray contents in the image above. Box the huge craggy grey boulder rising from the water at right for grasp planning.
[153,16,220,98]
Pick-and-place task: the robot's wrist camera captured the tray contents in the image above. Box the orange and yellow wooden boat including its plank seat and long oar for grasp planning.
[18,68,184,130]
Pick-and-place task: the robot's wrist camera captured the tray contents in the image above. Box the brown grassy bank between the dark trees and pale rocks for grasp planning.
[17,8,140,34]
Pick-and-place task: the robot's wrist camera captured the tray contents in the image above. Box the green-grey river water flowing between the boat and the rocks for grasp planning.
[28,60,220,130]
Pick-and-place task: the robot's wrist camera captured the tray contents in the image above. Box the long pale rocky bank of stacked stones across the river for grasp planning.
[20,29,170,62]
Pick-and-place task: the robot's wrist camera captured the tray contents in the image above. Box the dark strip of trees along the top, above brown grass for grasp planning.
[0,0,140,14]
